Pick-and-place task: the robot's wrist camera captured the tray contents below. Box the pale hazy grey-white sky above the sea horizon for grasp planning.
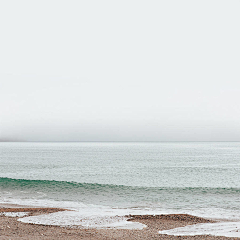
[0,0,240,141]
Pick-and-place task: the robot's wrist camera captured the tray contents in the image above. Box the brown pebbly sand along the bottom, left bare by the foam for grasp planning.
[0,207,240,240]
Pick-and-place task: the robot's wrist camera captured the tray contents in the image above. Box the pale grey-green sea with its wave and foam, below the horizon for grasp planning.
[0,142,240,237]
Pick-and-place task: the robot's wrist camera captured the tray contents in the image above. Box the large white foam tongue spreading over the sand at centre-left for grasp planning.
[1,199,155,229]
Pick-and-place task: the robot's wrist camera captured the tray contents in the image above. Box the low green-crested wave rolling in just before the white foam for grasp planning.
[0,177,240,210]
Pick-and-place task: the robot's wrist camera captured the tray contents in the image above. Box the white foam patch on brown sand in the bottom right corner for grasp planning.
[159,222,240,237]
